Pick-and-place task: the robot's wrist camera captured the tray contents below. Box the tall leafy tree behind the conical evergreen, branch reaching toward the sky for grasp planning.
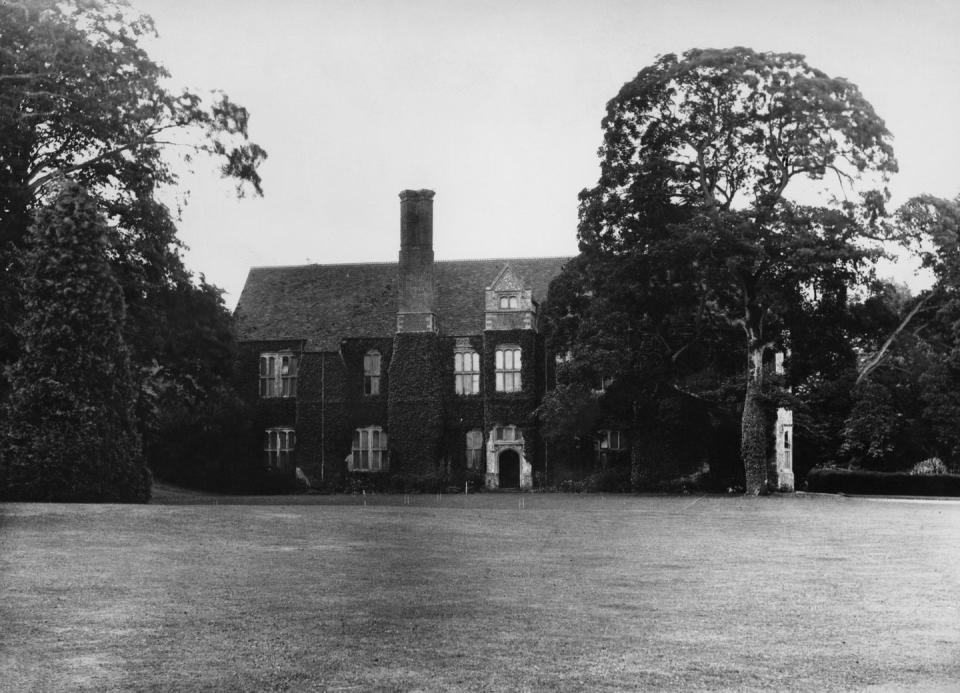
[0,0,266,492]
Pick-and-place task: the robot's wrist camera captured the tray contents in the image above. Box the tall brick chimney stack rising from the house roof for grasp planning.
[397,190,438,333]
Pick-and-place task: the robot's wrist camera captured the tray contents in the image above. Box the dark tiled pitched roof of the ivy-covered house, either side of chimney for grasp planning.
[236,257,570,351]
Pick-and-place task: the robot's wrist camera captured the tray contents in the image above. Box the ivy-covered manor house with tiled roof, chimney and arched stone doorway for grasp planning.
[237,190,568,489]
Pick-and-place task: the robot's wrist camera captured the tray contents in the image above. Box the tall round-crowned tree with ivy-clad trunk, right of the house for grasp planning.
[579,48,896,493]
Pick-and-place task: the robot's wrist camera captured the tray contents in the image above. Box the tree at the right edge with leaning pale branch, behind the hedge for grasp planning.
[843,195,960,470]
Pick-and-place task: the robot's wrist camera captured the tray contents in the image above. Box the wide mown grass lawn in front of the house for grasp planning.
[0,493,960,691]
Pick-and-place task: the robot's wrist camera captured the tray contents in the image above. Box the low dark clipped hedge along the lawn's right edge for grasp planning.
[807,469,960,496]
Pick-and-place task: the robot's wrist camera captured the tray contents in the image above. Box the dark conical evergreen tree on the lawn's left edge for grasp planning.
[0,183,150,502]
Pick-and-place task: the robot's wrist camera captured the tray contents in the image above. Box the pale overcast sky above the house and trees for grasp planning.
[132,0,960,308]
